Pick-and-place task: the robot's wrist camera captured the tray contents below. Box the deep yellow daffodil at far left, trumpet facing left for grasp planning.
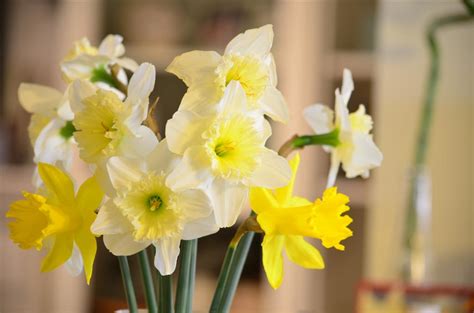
[6,163,103,283]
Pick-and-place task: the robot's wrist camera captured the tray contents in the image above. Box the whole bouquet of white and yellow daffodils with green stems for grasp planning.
[6,25,382,313]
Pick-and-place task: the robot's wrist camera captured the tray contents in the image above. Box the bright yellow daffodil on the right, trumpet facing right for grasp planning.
[250,154,352,289]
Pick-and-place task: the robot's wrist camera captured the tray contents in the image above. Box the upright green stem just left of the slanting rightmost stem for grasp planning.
[175,239,197,313]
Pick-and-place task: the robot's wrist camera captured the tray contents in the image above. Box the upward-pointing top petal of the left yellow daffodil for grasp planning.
[38,163,74,205]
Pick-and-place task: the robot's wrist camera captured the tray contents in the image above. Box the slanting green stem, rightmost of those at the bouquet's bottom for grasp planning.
[209,232,255,313]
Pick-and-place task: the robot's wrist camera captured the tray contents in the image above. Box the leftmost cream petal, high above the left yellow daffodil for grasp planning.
[18,83,63,114]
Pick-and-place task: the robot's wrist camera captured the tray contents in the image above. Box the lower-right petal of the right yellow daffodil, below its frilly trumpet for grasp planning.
[285,236,324,269]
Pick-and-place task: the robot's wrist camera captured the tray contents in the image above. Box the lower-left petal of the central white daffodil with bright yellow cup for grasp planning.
[166,146,213,191]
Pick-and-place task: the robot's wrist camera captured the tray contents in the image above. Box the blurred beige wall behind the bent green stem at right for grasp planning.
[365,0,474,284]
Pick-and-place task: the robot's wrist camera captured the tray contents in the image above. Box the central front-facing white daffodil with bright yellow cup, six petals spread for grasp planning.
[166,81,291,227]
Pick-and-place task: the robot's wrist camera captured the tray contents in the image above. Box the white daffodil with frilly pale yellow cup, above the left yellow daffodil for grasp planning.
[70,63,157,164]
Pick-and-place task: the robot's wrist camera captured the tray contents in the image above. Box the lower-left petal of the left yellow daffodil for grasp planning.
[41,233,73,272]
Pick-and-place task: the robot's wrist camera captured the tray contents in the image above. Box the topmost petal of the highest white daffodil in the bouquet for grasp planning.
[225,25,273,56]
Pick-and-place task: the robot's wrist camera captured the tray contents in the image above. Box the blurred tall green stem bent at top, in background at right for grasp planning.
[405,10,474,278]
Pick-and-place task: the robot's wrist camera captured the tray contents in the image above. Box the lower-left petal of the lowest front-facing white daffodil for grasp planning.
[91,199,133,235]
